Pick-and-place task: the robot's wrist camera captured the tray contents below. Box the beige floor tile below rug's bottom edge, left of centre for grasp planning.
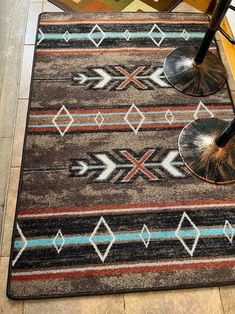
[24,295,125,314]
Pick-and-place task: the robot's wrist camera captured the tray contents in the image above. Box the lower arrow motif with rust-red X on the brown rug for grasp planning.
[69,149,186,183]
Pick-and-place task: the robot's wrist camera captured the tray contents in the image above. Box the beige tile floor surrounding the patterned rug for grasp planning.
[0,0,235,314]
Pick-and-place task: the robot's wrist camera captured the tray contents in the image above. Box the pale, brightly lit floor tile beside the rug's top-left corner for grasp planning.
[25,2,43,45]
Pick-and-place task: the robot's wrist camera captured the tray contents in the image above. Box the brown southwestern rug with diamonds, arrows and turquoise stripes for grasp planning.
[7,13,235,299]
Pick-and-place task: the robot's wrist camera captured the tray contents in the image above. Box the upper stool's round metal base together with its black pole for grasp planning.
[163,0,232,97]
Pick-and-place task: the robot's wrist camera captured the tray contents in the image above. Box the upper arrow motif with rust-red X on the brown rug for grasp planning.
[72,66,169,91]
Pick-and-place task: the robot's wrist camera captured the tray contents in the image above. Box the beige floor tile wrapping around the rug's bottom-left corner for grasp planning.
[0,258,23,314]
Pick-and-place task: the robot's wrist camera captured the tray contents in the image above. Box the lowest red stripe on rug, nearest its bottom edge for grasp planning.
[12,261,235,281]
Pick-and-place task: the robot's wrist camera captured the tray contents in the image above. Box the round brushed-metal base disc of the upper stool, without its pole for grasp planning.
[164,46,226,97]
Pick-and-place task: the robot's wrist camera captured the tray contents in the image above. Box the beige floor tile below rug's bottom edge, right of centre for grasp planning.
[125,288,223,314]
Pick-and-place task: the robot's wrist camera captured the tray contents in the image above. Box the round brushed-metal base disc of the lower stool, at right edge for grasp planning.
[179,118,235,184]
